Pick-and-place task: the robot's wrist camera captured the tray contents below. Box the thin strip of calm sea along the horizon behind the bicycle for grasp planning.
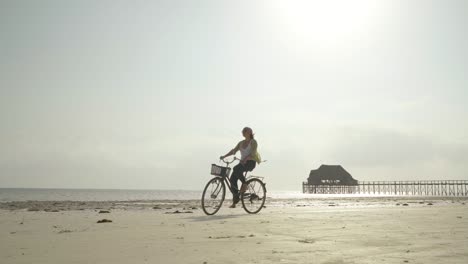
[0,188,313,202]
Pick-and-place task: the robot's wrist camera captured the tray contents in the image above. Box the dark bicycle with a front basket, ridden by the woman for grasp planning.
[202,157,266,215]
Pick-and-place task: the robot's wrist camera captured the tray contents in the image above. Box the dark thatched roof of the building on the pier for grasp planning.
[307,165,357,185]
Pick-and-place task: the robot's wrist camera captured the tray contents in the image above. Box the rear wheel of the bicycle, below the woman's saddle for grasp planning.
[241,178,266,214]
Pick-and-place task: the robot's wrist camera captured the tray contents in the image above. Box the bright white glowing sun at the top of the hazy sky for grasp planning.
[269,0,382,44]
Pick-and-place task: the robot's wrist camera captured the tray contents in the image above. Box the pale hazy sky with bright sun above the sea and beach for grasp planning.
[0,0,468,190]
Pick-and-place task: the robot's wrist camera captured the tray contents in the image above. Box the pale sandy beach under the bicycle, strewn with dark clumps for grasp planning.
[0,198,468,264]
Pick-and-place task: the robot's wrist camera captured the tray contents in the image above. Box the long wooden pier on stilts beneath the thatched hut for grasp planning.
[302,180,468,196]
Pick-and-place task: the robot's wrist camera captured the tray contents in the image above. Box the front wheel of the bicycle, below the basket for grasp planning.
[202,177,226,215]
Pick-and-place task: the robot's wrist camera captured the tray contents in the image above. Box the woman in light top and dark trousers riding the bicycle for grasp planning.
[220,127,261,208]
